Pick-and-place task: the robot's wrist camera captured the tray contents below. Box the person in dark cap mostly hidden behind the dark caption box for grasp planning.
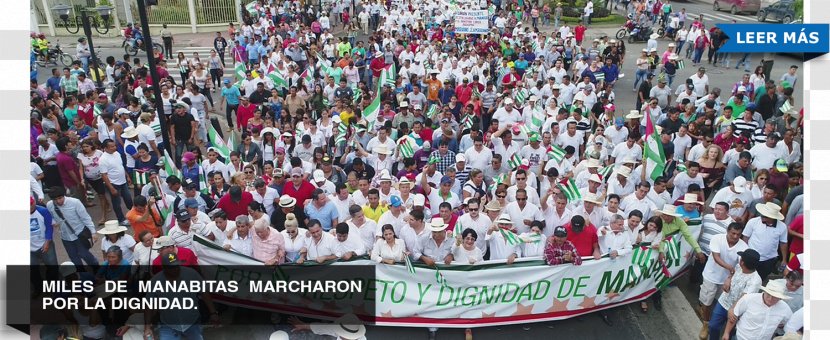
[144,251,219,339]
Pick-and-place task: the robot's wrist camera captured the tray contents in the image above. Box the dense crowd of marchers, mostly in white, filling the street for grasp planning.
[30,0,803,339]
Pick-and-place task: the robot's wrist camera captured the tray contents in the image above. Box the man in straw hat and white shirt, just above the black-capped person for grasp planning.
[743,202,789,280]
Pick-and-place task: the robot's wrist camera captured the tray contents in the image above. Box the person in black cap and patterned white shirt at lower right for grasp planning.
[701,247,768,340]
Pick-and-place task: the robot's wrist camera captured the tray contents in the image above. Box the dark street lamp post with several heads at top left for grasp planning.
[52,4,113,91]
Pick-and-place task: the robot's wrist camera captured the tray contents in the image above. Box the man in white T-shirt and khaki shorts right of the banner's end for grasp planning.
[698,222,748,339]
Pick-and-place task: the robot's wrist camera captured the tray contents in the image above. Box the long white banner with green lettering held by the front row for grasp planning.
[194,225,700,328]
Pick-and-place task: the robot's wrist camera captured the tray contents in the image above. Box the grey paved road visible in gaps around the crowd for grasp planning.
[29,2,801,340]
